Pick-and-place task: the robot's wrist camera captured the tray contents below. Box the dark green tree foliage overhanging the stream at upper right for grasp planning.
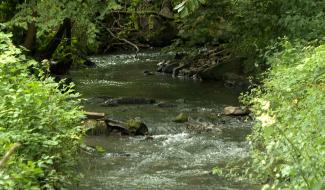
[175,0,325,74]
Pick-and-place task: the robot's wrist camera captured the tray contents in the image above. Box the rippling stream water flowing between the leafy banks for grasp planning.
[71,52,253,190]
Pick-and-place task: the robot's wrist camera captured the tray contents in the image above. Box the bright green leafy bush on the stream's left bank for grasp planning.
[0,32,83,190]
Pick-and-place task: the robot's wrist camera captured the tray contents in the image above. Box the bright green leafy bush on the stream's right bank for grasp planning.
[244,42,325,189]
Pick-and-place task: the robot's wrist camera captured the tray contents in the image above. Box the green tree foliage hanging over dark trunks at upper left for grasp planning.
[0,0,121,51]
